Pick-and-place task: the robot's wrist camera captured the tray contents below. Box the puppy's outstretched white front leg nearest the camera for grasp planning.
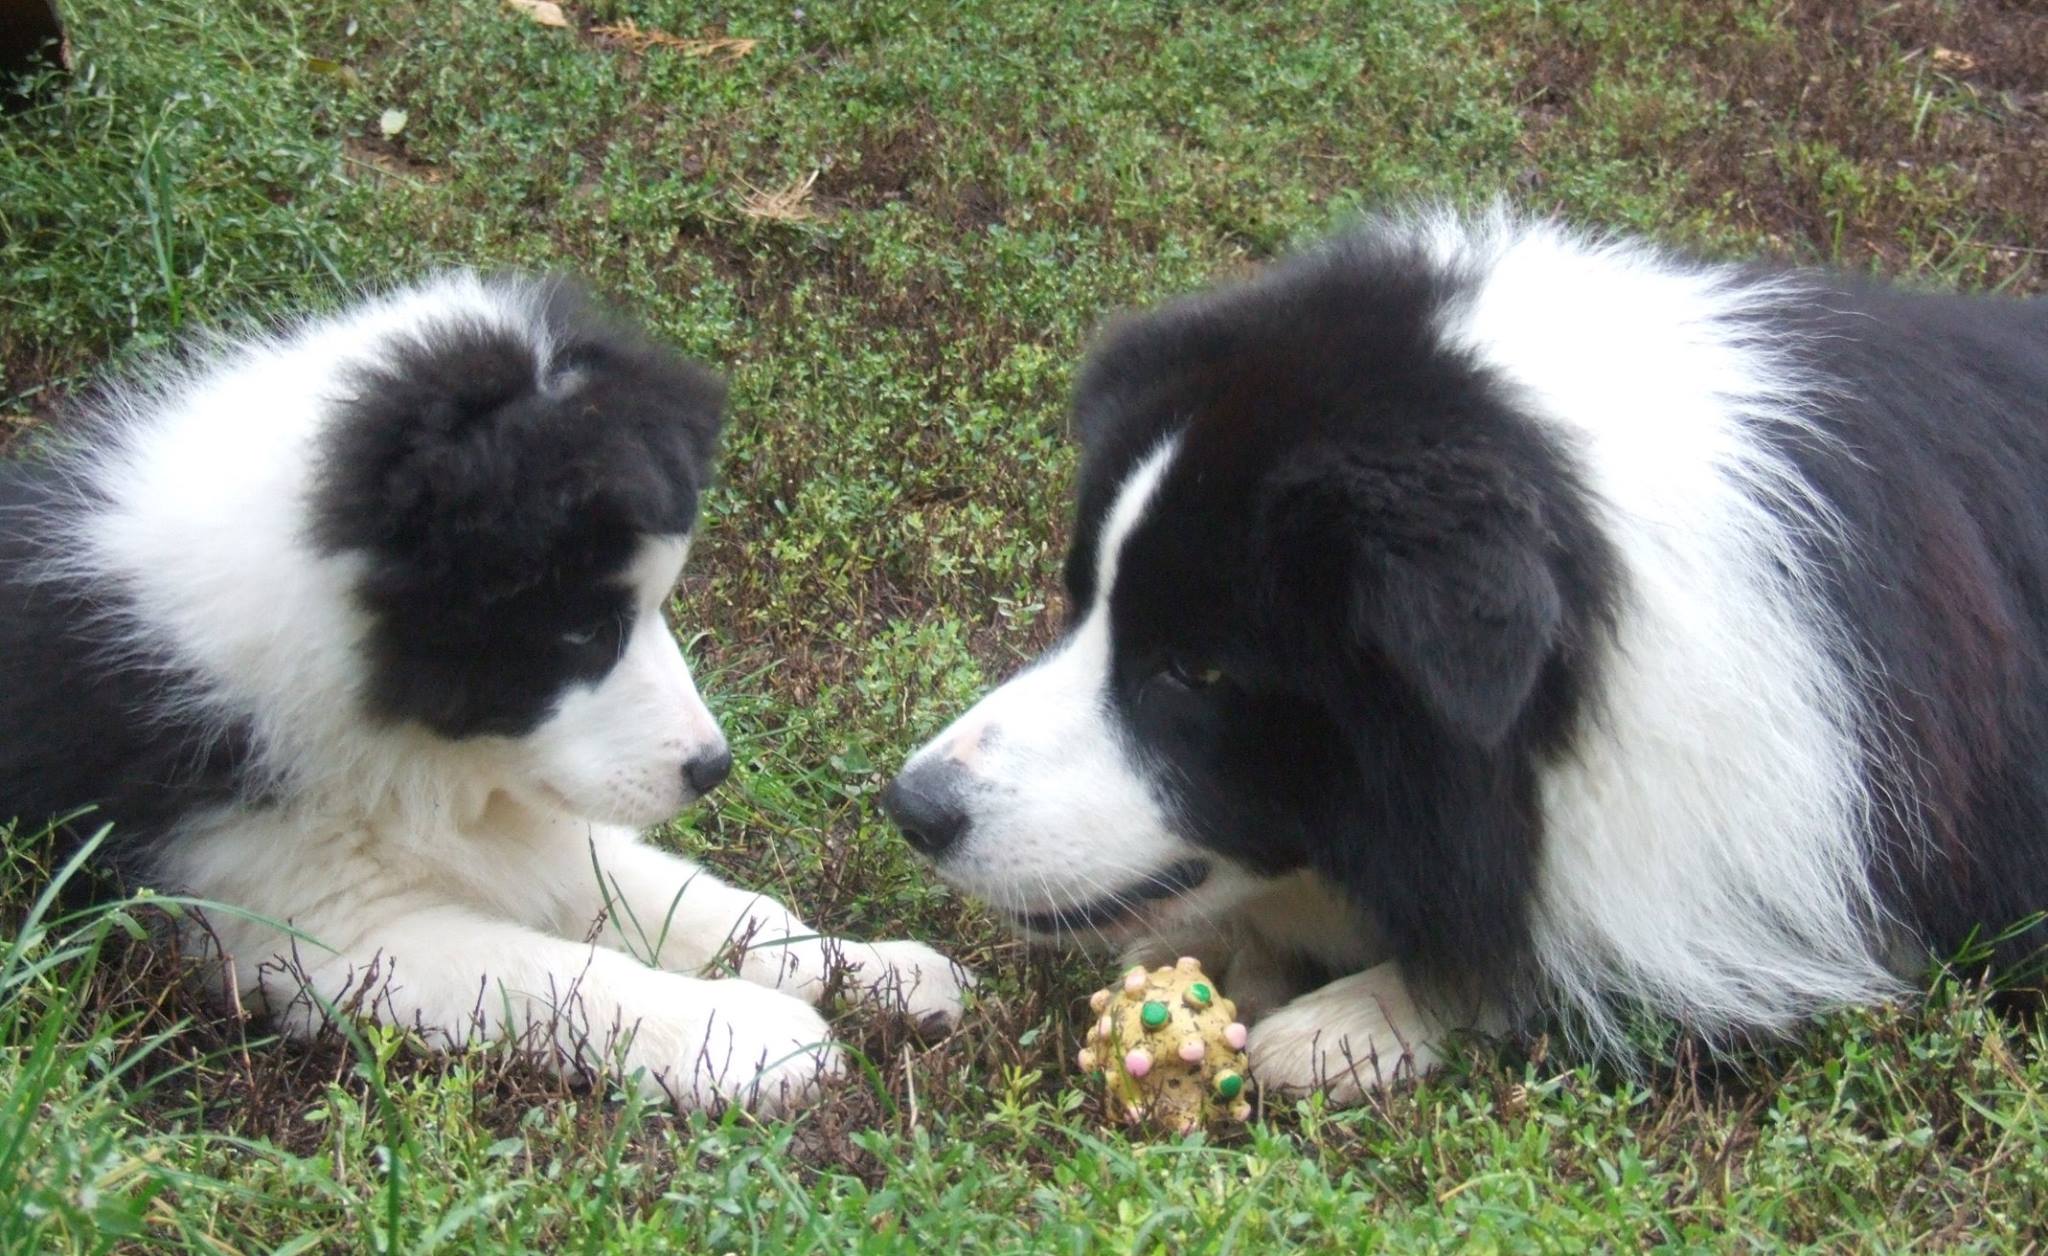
[253,906,842,1111]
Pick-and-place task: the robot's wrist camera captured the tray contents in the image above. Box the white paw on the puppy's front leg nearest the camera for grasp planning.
[625,977,846,1113]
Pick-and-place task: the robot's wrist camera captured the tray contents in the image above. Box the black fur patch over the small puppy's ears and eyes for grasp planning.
[313,284,723,738]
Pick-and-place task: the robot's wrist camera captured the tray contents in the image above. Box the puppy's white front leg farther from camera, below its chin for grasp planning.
[578,838,973,1033]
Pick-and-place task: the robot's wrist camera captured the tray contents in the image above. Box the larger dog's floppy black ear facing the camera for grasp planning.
[1260,449,1565,746]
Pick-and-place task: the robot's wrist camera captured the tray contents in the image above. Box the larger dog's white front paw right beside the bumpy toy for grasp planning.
[1247,963,1440,1104]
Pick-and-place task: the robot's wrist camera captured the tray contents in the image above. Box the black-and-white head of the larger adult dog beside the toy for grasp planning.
[885,230,1597,940]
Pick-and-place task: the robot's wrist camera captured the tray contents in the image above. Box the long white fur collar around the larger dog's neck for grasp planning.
[1425,215,1896,1035]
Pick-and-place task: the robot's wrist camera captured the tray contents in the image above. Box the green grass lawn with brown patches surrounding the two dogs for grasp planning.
[0,0,2048,1252]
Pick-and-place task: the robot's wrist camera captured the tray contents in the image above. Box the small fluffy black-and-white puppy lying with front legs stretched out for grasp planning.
[0,273,967,1108]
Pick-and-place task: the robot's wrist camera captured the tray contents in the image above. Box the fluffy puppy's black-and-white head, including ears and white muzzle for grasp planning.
[313,281,731,824]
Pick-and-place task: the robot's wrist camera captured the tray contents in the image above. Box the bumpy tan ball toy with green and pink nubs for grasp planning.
[1077,957,1251,1133]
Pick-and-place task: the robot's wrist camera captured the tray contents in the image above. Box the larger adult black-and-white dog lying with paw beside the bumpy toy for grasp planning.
[885,211,2048,1098]
